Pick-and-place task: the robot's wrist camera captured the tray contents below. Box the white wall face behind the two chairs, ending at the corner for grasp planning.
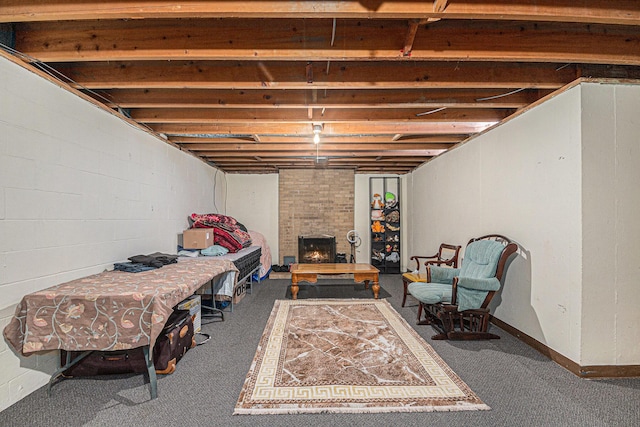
[411,88,581,361]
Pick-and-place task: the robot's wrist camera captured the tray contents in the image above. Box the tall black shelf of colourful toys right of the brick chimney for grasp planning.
[369,177,401,274]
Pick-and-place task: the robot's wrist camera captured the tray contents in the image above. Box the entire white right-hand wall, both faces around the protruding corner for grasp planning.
[409,84,640,366]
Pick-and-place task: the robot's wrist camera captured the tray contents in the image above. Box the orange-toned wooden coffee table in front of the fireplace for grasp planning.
[289,263,380,299]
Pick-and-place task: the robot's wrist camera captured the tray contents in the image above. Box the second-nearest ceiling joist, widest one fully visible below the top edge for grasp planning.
[15,19,640,65]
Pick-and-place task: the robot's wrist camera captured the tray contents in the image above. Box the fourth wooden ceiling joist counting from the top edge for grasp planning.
[94,89,551,109]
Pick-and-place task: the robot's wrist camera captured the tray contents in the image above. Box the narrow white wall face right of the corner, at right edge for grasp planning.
[581,84,640,366]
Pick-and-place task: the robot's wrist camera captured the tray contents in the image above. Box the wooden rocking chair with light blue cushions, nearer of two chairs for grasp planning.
[407,234,518,339]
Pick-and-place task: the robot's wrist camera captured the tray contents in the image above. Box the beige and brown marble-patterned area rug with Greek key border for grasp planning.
[234,299,490,415]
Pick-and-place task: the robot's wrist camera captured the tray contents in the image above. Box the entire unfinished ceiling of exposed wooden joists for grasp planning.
[0,0,640,174]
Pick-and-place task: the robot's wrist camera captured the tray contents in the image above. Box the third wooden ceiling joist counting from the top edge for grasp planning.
[55,61,578,90]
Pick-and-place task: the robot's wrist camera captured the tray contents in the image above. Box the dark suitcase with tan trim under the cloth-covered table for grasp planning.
[60,310,196,377]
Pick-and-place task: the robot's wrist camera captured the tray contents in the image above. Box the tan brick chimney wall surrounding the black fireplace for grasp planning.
[274,169,355,264]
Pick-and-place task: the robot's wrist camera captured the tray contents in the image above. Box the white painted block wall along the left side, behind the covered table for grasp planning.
[0,57,224,410]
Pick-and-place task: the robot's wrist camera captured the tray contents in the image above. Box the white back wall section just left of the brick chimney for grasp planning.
[225,174,280,263]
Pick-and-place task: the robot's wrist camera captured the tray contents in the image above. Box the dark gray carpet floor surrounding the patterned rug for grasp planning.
[0,275,640,427]
